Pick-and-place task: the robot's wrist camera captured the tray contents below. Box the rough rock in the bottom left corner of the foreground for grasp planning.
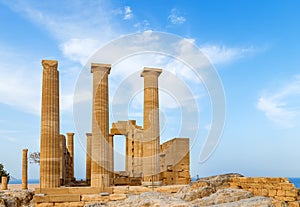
[0,190,34,207]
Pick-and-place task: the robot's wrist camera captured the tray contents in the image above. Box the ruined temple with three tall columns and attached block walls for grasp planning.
[36,60,190,202]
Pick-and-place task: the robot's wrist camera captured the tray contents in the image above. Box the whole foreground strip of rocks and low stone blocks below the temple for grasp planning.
[4,174,300,207]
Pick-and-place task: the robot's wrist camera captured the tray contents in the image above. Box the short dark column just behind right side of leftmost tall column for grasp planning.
[59,134,67,185]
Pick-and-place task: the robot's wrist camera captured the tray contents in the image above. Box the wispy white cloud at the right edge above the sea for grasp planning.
[256,76,300,128]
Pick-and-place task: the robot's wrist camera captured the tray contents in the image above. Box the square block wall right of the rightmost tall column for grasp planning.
[160,138,190,185]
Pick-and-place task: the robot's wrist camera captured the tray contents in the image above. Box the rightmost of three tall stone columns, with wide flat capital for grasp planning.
[141,68,162,185]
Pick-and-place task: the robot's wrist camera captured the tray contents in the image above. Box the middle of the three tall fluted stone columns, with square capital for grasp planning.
[91,63,111,190]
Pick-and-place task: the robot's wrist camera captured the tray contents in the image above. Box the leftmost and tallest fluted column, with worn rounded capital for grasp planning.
[40,60,60,188]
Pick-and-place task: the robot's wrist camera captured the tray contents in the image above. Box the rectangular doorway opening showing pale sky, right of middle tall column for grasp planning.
[114,135,126,172]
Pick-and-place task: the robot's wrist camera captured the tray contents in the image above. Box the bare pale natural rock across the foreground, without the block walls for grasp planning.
[0,174,300,207]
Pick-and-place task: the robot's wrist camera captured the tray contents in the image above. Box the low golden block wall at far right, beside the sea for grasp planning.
[229,177,300,206]
